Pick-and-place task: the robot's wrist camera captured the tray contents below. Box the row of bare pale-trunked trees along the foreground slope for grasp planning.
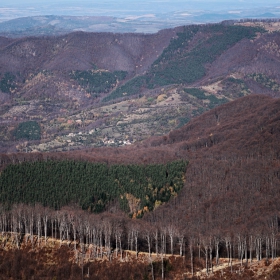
[0,201,279,273]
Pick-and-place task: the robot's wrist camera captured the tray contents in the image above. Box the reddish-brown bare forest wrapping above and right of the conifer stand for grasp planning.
[1,95,280,226]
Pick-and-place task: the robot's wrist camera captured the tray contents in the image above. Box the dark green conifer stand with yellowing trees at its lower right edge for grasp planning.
[0,160,187,217]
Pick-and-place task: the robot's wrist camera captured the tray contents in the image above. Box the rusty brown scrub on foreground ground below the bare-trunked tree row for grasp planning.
[0,245,280,280]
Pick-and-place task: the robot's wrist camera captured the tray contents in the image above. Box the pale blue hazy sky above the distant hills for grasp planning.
[0,0,280,21]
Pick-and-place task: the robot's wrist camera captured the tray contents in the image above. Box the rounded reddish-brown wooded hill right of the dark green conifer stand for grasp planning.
[143,95,280,243]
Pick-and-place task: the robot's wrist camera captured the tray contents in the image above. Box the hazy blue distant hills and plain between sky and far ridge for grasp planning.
[0,11,279,37]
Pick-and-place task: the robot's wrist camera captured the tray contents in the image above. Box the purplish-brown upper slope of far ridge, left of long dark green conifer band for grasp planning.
[0,29,178,73]
